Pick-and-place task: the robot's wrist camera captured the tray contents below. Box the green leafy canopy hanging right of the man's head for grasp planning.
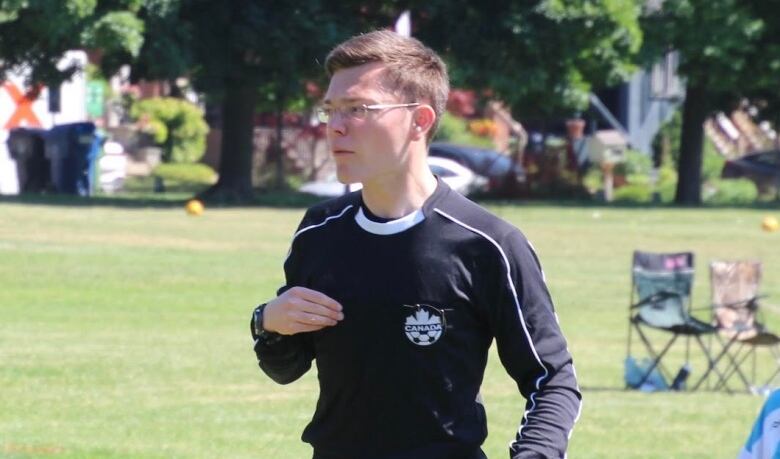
[419,0,643,116]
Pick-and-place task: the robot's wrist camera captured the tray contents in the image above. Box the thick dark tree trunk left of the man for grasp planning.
[203,84,257,202]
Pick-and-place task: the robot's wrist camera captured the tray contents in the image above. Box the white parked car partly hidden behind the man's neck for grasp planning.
[299,156,487,197]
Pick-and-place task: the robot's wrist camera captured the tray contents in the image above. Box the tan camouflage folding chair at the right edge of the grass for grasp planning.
[710,260,780,392]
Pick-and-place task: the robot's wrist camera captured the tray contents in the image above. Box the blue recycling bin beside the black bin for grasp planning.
[46,123,103,196]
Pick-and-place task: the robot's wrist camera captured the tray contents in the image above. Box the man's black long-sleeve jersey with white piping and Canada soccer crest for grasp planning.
[254,181,581,459]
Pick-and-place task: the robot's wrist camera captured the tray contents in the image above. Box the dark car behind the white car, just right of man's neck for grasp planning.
[428,142,525,191]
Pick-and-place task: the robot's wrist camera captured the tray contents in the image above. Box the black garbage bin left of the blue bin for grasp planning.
[6,128,52,193]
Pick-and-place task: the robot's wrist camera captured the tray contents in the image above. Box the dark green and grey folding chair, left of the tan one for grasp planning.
[626,251,722,390]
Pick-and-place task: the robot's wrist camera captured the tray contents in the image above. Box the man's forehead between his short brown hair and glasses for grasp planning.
[323,62,392,104]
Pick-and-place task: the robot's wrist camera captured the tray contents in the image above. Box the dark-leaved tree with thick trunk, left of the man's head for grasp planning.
[157,0,374,200]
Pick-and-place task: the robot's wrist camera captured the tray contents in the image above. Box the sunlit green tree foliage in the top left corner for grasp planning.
[0,0,144,85]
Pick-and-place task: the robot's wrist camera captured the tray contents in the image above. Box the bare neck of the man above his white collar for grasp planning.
[362,155,436,219]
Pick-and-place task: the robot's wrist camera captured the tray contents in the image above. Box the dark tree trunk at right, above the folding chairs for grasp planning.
[674,86,708,205]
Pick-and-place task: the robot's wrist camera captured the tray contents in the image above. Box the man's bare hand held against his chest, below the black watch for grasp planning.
[263,287,344,335]
